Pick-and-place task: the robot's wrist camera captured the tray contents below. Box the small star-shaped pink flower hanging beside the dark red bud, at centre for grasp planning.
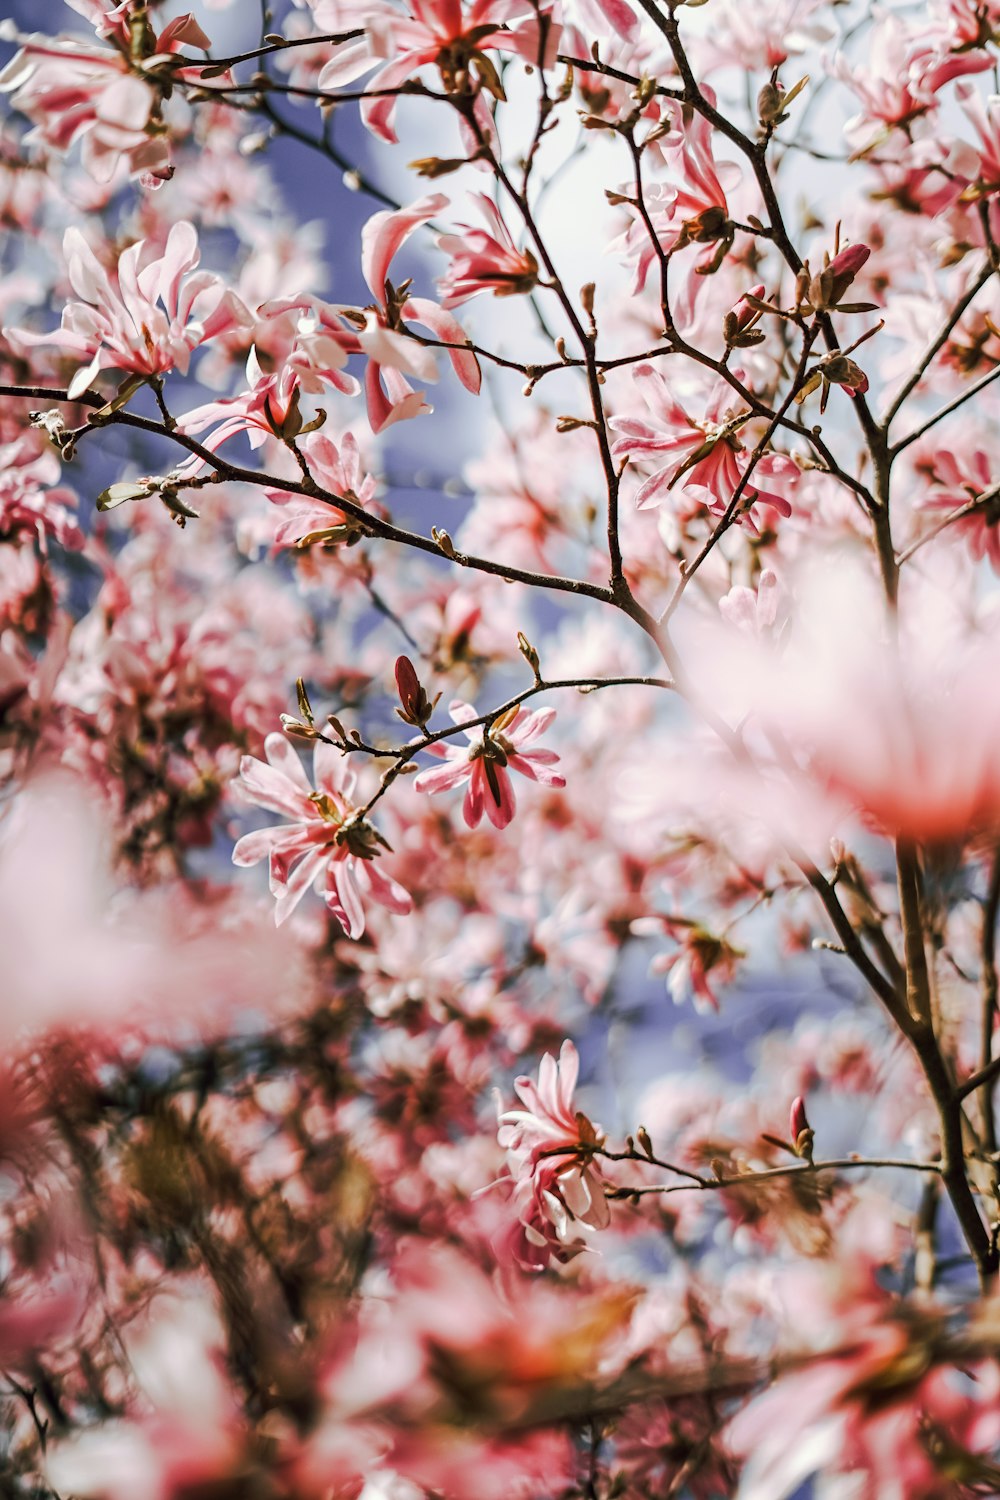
[414,699,565,828]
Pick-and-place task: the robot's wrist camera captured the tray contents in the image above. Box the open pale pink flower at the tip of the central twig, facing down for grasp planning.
[232,735,412,938]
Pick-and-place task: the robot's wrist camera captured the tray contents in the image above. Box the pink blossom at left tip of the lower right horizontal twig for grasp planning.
[496,1041,610,1268]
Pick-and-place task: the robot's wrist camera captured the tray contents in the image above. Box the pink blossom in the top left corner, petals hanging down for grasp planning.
[0,0,211,186]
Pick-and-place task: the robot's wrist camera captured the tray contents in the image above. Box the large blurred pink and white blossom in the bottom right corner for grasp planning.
[727,1254,1000,1500]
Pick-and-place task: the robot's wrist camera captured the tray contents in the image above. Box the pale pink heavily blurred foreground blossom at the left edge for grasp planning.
[0,774,298,1056]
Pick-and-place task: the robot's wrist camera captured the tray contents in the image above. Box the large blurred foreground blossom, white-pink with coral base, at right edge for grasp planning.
[740,567,1000,843]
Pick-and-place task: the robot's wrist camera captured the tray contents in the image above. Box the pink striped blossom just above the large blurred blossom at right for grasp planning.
[610,365,798,530]
